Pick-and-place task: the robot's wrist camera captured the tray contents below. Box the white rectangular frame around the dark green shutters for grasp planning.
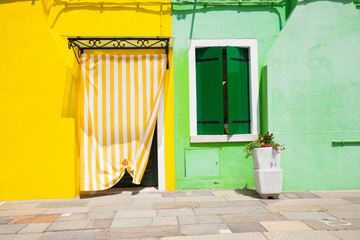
[189,39,259,143]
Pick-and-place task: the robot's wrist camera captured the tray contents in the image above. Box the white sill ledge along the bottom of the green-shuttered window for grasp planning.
[190,134,259,143]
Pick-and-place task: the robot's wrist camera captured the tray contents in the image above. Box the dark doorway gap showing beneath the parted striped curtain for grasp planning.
[113,127,158,188]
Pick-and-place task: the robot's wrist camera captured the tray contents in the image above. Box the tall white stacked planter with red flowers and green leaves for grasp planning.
[244,132,285,199]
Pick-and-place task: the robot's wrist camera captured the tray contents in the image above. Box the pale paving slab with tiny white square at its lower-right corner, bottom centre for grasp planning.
[180,224,229,235]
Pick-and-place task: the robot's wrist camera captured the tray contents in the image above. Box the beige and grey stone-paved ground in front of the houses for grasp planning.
[0,188,360,240]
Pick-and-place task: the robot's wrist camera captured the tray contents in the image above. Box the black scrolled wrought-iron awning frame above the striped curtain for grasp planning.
[67,36,170,69]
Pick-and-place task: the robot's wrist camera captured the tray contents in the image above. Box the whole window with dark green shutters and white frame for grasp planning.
[189,39,259,142]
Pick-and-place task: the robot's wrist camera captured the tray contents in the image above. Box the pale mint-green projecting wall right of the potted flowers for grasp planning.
[263,0,360,191]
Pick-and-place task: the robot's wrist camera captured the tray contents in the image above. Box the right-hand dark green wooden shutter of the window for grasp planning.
[226,46,250,134]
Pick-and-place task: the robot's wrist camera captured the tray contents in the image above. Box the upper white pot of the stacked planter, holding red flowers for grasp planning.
[251,147,280,170]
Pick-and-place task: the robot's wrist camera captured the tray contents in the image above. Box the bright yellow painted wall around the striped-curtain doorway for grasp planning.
[0,0,175,201]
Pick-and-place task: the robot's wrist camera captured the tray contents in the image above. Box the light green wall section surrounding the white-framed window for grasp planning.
[172,2,287,189]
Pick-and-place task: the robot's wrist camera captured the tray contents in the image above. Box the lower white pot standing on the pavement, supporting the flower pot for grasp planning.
[253,168,283,199]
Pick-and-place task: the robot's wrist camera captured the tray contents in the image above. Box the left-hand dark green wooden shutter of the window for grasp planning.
[196,47,224,135]
